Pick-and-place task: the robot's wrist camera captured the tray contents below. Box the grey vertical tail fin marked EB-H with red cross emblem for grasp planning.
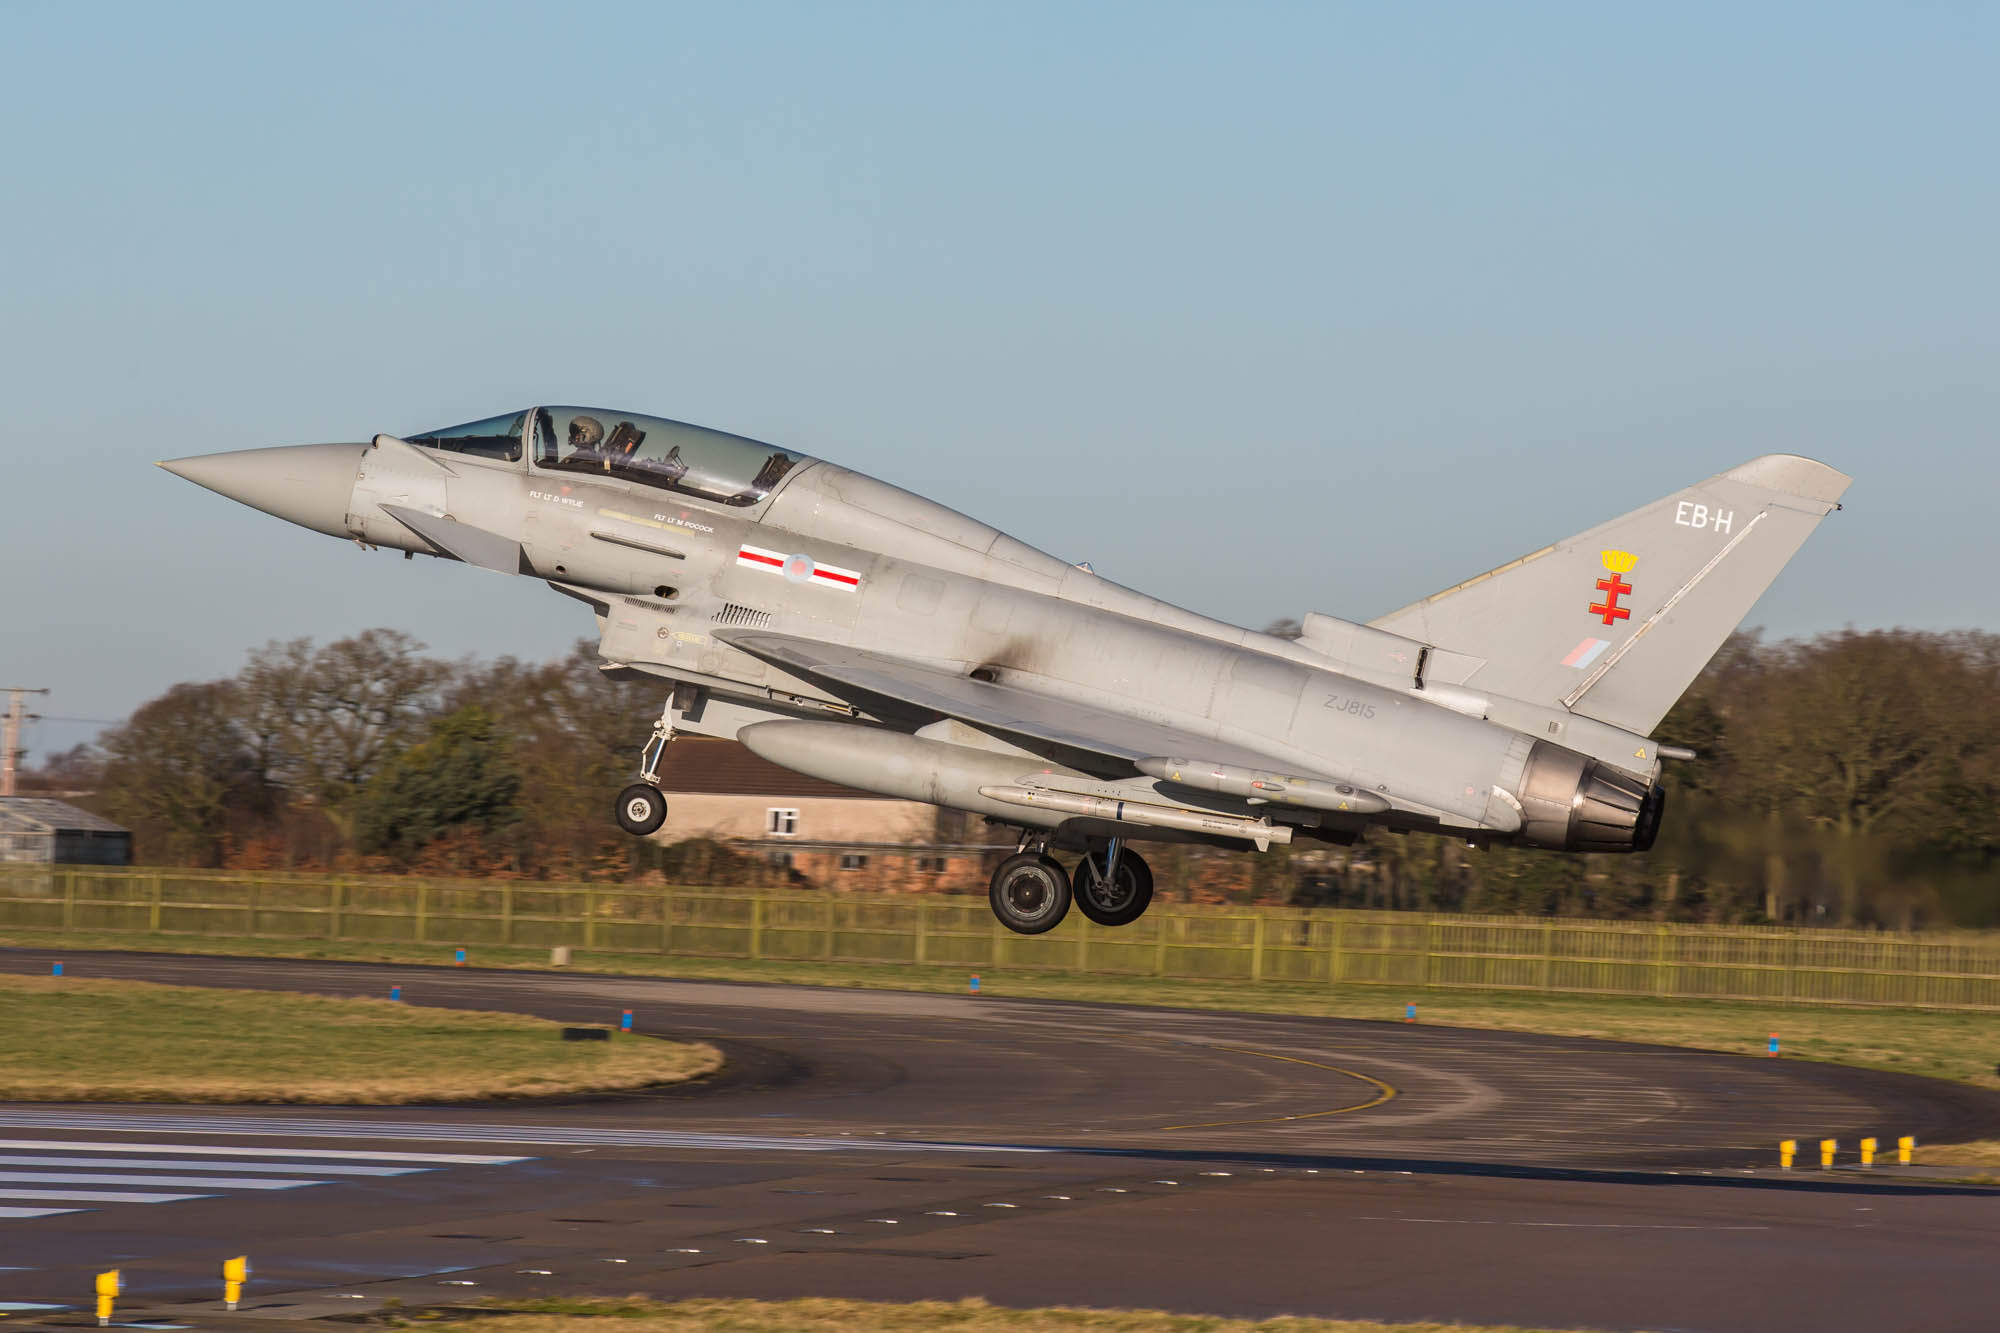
[1370,454,1852,735]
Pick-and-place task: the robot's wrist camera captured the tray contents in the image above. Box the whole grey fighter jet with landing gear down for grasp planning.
[160,406,1850,935]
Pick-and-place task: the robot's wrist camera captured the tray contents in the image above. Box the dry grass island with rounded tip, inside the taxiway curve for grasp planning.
[0,964,722,1105]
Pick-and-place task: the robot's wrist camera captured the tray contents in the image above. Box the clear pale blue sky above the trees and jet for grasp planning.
[0,0,2000,749]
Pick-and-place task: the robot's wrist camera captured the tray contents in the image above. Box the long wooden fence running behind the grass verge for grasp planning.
[0,867,2000,1011]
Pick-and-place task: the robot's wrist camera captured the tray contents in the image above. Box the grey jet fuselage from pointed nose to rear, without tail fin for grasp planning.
[160,408,1658,845]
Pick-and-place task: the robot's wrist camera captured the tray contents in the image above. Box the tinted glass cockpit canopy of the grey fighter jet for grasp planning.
[408,406,806,506]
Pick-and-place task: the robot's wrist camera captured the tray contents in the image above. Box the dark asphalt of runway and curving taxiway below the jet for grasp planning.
[0,951,2000,1331]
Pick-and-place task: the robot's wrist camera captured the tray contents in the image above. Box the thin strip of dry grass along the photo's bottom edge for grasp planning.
[406,1297,1624,1333]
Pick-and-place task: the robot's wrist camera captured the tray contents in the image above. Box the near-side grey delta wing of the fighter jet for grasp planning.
[716,628,1340,781]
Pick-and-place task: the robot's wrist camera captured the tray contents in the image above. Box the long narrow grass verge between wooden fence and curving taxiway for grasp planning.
[0,931,2000,1087]
